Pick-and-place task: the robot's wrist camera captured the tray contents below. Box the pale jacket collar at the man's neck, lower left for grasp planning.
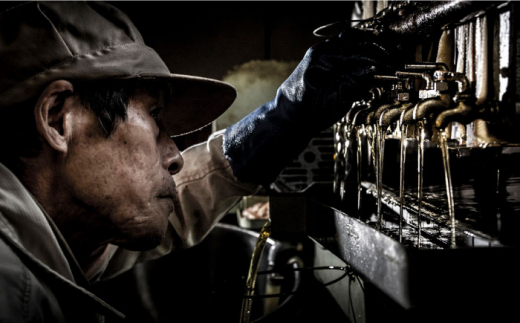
[0,163,124,318]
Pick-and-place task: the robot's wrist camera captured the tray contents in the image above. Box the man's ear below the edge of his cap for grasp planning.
[34,80,74,153]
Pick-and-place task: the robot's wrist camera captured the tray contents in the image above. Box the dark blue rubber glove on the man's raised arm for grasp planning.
[223,29,399,185]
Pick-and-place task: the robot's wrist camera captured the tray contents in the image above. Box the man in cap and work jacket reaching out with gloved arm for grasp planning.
[0,2,389,322]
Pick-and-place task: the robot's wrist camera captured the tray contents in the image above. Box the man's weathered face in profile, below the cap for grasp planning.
[65,92,183,250]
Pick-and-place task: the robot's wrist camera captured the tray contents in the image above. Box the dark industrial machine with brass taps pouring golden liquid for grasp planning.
[271,1,520,322]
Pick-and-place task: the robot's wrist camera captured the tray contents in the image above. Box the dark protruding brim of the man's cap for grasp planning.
[154,74,237,136]
